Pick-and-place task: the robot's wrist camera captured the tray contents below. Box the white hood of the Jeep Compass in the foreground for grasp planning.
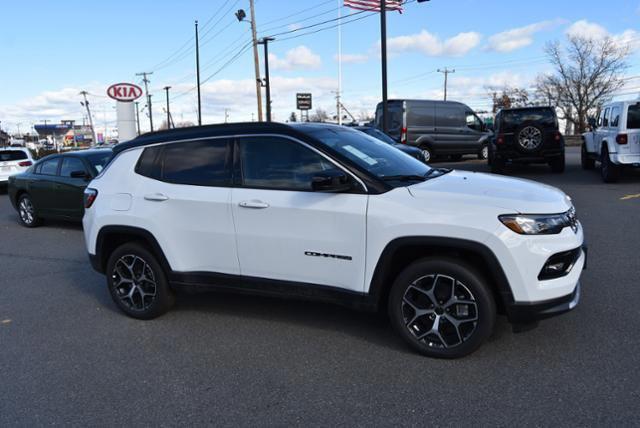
[408,171,571,214]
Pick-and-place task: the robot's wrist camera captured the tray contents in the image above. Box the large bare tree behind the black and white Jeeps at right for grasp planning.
[536,36,629,133]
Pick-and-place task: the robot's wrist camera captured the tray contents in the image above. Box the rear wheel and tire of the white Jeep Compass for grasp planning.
[106,242,175,320]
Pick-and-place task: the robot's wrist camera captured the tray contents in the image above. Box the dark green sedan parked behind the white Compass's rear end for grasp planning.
[8,149,112,227]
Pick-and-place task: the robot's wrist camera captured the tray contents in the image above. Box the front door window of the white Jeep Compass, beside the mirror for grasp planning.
[240,137,338,191]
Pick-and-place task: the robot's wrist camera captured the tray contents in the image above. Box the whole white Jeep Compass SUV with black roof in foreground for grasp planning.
[83,123,586,358]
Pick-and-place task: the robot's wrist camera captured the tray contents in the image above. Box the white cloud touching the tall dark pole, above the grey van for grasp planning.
[387,30,482,56]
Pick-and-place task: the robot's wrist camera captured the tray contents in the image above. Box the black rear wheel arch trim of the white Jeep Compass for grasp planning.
[96,226,171,274]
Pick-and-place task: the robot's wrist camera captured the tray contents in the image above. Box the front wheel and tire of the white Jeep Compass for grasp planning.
[388,257,496,358]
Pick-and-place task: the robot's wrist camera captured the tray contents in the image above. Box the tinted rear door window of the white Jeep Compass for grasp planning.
[159,139,231,186]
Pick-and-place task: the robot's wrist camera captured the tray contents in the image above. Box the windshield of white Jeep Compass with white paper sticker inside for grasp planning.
[305,126,435,181]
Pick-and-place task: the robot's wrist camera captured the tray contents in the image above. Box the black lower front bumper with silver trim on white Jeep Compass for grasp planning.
[506,282,580,324]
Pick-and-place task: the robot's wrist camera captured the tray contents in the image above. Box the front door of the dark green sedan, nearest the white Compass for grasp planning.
[53,156,89,219]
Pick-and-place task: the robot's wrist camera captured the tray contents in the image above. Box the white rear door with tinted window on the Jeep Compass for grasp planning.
[132,138,240,275]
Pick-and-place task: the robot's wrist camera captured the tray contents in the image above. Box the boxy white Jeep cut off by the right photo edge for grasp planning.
[582,101,640,183]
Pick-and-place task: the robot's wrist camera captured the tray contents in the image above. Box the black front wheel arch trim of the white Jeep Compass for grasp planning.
[369,236,514,312]
